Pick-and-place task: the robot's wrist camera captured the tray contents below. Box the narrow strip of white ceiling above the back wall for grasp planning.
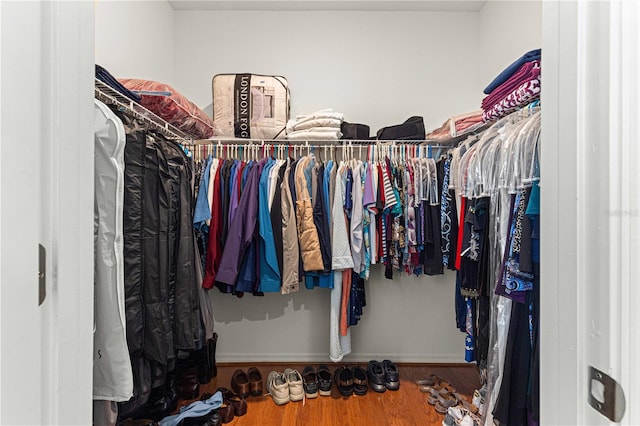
[169,0,486,12]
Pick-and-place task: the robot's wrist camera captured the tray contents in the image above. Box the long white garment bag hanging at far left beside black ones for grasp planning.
[93,100,133,401]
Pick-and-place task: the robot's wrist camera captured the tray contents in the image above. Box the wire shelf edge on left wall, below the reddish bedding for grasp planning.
[95,78,193,145]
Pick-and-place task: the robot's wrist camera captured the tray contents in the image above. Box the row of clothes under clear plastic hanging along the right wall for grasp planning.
[450,108,541,425]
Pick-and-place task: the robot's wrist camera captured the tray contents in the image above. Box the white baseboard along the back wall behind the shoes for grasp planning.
[216,353,464,364]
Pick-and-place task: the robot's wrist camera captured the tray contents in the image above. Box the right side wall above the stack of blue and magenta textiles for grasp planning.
[477,0,542,92]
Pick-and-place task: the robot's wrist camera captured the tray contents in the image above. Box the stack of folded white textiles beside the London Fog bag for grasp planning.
[287,109,344,141]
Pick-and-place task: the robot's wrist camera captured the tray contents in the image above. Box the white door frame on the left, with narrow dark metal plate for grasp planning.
[0,1,94,425]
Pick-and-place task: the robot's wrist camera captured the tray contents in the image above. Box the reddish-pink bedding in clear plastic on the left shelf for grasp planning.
[119,78,215,139]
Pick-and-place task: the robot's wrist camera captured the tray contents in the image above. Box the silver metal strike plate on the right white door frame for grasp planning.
[589,366,626,422]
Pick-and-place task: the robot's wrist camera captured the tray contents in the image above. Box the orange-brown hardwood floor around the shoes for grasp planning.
[179,363,480,426]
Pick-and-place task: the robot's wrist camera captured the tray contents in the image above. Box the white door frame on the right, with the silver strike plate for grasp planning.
[541,1,640,425]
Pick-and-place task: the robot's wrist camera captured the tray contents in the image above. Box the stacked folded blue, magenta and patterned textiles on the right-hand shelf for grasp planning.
[482,49,542,121]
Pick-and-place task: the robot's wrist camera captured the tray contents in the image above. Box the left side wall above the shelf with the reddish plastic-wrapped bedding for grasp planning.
[95,0,179,85]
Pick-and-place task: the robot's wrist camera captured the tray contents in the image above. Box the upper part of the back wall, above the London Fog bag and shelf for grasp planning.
[175,11,480,133]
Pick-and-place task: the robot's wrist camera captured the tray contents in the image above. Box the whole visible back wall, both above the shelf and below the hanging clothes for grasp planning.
[175,11,481,362]
